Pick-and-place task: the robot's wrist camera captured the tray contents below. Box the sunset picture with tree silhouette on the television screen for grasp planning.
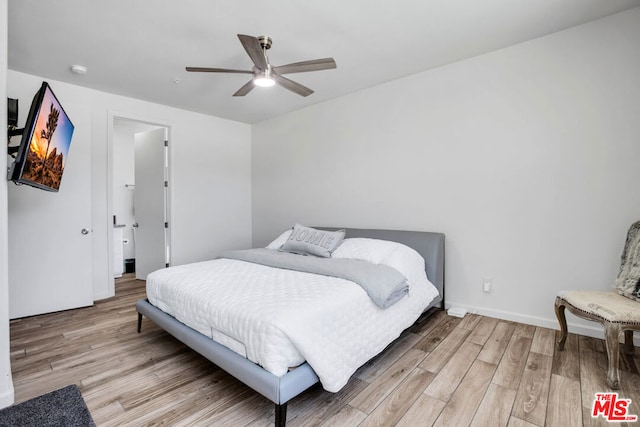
[22,87,74,190]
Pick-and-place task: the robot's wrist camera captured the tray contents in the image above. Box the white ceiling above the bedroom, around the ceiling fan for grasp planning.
[8,0,640,123]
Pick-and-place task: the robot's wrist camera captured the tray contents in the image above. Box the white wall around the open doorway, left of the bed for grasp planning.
[7,70,251,299]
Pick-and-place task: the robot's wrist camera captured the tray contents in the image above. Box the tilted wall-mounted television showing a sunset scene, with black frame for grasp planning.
[8,82,74,191]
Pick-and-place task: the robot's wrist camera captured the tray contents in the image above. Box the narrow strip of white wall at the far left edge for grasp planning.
[0,0,14,408]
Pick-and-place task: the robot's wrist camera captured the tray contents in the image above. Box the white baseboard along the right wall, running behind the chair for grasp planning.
[445,301,640,346]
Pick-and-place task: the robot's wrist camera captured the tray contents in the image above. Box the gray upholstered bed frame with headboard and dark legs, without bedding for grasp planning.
[136,227,445,427]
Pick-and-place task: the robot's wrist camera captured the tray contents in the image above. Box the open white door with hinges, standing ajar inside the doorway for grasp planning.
[133,128,167,280]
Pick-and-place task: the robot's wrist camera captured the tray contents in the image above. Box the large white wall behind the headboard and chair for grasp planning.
[252,8,640,340]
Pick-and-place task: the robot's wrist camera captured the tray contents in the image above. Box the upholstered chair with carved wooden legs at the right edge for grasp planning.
[555,221,640,390]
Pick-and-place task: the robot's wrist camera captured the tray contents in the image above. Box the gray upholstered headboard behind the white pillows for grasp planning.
[316,227,445,309]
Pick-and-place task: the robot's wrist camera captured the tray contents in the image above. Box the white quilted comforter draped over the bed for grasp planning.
[147,252,438,392]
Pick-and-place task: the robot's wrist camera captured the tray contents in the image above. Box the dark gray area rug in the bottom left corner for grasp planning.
[0,385,96,427]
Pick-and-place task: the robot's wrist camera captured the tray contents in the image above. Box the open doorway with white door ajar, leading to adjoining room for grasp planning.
[110,117,170,280]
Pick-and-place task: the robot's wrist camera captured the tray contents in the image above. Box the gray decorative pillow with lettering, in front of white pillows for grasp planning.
[280,224,344,258]
